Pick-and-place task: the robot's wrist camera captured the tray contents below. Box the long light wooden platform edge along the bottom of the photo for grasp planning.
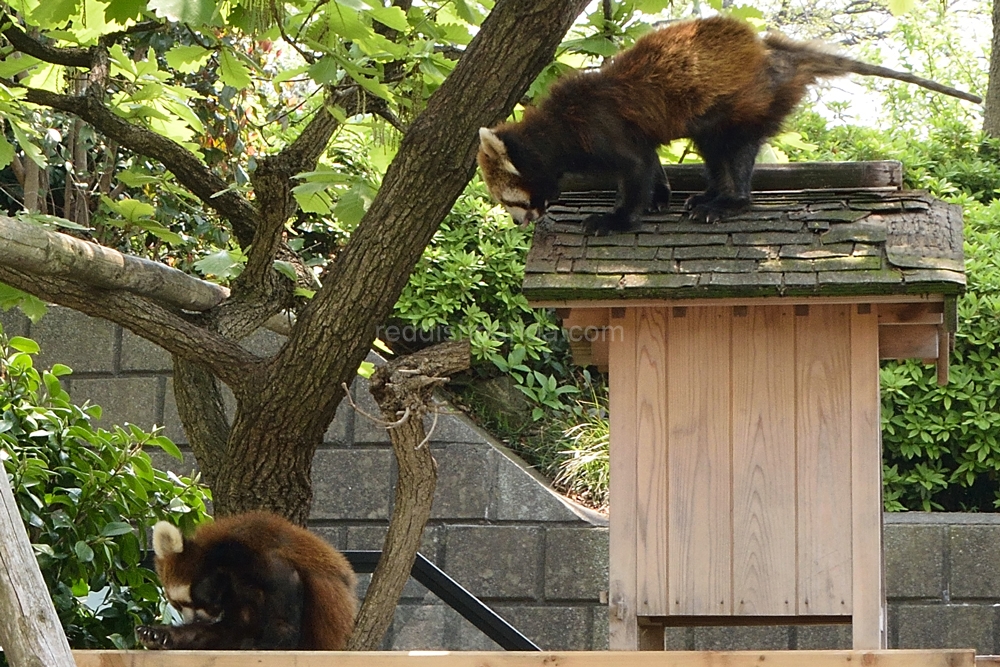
[73,649,976,667]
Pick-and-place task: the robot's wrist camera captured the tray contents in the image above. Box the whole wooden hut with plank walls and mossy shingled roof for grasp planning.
[524,162,965,649]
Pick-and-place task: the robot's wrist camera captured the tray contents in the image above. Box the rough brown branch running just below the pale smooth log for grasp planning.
[0,266,262,391]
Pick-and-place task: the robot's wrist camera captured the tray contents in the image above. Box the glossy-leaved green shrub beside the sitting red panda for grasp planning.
[0,330,207,648]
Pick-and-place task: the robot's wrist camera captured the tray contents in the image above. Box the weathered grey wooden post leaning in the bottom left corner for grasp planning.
[0,462,76,667]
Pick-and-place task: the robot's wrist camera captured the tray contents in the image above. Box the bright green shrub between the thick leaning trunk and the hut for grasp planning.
[390,179,580,421]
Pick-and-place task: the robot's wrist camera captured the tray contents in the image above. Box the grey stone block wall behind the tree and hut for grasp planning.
[0,308,1000,653]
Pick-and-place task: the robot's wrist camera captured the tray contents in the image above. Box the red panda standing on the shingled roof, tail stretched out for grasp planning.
[478,16,982,234]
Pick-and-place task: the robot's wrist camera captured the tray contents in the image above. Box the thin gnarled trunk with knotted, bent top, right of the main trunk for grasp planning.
[347,341,470,651]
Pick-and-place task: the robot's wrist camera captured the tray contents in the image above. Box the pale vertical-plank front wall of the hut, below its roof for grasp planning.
[610,304,885,649]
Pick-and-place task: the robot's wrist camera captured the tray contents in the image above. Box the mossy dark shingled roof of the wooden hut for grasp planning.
[523,162,965,303]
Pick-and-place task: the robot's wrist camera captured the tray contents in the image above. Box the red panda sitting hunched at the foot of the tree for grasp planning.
[136,512,357,651]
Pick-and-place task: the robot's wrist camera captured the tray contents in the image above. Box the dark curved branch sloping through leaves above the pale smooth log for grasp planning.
[15,86,256,247]
